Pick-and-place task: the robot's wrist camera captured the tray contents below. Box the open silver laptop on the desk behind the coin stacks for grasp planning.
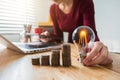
[0,35,61,54]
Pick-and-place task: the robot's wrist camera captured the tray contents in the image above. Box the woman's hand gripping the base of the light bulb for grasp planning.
[83,41,113,66]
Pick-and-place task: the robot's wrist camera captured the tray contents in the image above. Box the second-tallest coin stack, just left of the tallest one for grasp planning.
[51,50,60,66]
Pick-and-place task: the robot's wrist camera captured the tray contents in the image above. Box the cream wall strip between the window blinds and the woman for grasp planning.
[34,0,52,23]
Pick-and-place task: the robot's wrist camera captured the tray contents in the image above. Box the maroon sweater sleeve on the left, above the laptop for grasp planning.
[50,4,63,42]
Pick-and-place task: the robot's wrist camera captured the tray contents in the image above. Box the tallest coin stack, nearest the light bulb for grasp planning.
[62,43,71,67]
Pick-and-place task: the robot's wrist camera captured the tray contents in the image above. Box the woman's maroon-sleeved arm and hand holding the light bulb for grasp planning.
[83,0,113,66]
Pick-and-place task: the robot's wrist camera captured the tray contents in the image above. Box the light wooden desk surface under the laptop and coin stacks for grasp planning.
[0,45,120,80]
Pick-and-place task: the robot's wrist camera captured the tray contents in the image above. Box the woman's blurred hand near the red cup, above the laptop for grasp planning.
[40,31,52,43]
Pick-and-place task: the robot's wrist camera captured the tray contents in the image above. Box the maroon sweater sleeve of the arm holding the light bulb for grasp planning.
[83,0,99,41]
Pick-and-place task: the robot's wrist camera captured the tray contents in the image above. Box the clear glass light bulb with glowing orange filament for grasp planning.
[72,26,95,62]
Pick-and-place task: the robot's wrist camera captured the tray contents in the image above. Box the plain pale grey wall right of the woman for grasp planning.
[94,0,120,52]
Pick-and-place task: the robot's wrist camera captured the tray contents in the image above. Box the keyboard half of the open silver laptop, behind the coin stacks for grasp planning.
[14,42,61,53]
